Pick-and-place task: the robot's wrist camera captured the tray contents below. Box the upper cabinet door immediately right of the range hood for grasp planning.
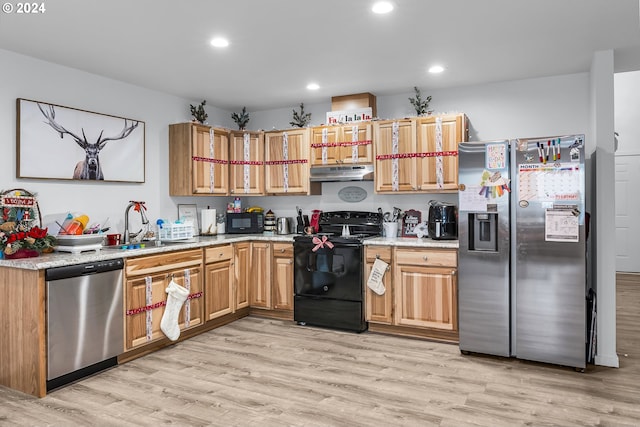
[374,119,418,193]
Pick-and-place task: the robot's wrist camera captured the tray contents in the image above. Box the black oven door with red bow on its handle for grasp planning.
[293,239,363,301]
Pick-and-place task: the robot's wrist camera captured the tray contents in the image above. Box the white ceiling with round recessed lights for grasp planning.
[0,0,640,111]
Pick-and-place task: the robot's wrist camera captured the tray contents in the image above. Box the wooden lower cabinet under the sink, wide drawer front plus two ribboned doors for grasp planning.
[124,250,204,350]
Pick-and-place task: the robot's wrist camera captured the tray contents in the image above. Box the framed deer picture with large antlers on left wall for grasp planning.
[16,98,145,183]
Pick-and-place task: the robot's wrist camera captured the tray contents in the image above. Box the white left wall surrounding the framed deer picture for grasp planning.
[0,50,230,231]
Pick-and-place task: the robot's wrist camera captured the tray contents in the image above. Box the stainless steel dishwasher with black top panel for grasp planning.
[45,258,124,390]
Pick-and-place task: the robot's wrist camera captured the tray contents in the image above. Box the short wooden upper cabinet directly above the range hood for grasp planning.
[311,122,373,166]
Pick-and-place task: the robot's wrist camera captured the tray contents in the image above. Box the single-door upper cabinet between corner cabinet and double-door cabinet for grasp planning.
[229,131,264,195]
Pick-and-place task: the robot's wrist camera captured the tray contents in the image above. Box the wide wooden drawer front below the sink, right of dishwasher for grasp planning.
[124,249,202,277]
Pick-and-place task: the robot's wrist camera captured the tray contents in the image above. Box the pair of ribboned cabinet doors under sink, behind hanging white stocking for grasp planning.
[125,267,204,350]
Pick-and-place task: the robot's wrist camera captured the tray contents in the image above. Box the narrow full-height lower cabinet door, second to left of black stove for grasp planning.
[249,242,271,309]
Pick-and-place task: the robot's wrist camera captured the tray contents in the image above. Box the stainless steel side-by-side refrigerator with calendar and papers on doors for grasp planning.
[458,135,587,368]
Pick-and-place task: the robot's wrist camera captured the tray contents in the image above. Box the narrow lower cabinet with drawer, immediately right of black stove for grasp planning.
[364,246,393,325]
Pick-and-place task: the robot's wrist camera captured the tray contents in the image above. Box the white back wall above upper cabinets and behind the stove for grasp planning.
[246,73,590,219]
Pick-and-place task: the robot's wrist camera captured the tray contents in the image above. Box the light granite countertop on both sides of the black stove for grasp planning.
[0,234,458,270]
